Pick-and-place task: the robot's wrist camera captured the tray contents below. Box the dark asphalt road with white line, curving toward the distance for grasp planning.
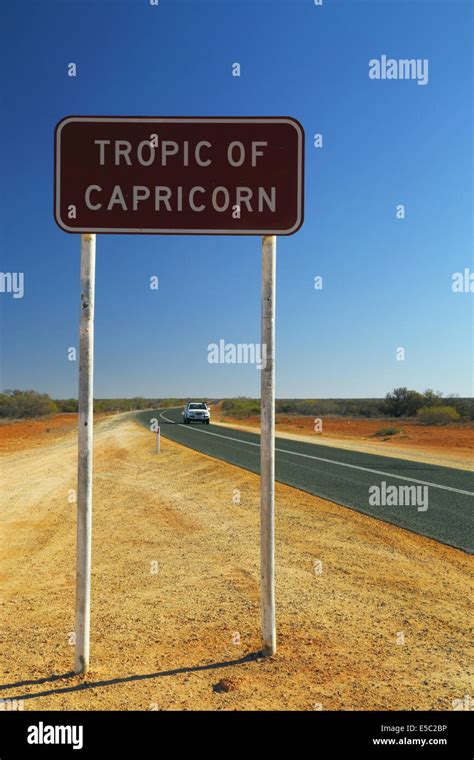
[137,409,474,553]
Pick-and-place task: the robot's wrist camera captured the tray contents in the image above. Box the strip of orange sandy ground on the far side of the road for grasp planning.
[212,406,474,470]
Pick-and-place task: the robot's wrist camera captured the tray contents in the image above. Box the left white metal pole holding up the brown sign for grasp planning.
[74,234,96,673]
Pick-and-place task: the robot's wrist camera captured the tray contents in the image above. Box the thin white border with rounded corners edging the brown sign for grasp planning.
[54,116,305,237]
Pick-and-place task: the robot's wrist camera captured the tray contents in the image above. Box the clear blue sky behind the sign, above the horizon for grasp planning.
[0,0,473,398]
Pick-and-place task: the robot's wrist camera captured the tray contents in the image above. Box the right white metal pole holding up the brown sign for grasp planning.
[260,235,276,655]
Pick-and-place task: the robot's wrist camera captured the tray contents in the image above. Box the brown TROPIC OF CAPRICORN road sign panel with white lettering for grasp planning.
[54,116,304,235]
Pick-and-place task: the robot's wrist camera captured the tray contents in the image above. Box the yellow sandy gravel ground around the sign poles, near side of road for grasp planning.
[0,416,473,710]
